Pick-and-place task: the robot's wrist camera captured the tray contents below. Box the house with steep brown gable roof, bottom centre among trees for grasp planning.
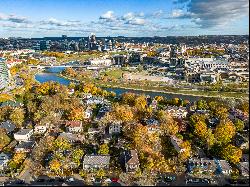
[124,150,140,172]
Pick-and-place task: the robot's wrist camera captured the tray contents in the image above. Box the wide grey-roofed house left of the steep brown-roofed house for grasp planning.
[83,155,110,170]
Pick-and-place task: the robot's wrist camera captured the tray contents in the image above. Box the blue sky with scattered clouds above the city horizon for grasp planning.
[0,0,249,38]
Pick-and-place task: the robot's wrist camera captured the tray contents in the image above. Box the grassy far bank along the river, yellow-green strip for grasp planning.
[58,73,248,99]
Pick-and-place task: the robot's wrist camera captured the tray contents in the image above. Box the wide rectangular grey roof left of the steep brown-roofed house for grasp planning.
[83,155,110,165]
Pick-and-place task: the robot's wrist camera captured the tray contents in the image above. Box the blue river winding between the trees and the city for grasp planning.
[35,67,201,101]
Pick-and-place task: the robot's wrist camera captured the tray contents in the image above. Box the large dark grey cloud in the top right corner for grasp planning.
[175,0,249,28]
